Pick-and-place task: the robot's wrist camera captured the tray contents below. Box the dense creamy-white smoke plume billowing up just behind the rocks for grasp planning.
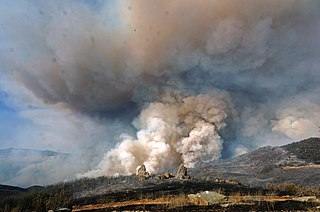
[84,94,234,177]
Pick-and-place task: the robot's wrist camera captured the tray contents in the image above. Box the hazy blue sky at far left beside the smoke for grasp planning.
[0,0,114,151]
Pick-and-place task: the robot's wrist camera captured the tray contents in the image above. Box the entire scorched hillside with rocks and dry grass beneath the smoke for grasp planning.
[0,138,320,211]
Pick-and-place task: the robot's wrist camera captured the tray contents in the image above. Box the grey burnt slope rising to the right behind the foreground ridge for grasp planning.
[190,138,320,186]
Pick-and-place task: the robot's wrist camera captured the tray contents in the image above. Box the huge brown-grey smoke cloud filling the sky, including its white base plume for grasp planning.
[0,0,320,183]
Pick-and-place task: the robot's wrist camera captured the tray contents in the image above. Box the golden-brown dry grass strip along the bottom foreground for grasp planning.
[73,190,318,211]
